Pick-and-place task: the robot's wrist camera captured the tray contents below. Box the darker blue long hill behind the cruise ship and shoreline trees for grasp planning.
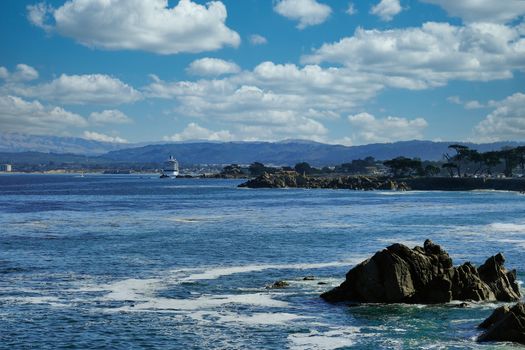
[101,141,518,166]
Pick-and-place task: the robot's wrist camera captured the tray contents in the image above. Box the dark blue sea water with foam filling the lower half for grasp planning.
[0,175,525,349]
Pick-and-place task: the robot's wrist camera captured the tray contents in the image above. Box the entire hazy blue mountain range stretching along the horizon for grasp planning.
[0,134,523,166]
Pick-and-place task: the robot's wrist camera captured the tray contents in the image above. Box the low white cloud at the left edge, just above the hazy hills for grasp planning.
[0,95,87,134]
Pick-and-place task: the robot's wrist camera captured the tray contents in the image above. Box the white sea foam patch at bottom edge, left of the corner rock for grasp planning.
[288,327,360,350]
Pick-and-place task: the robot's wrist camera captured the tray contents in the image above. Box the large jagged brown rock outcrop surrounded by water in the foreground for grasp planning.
[321,240,520,304]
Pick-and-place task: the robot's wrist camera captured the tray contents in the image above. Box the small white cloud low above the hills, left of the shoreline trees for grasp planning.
[345,113,428,145]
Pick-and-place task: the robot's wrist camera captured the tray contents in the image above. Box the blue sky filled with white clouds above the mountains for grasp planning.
[0,0,525,145]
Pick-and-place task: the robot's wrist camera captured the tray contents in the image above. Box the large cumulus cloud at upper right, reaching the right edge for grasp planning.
[302,22,525,89]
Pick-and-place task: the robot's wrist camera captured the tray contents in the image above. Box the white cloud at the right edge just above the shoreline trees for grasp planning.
[474,92,525,142]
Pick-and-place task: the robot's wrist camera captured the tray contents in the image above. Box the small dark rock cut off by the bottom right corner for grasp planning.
[478,303,525,344]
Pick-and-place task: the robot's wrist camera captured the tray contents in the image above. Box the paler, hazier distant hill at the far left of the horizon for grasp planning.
[0,133,140,155]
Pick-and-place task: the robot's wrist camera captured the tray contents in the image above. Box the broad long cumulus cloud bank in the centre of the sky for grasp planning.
[145,62,383,137]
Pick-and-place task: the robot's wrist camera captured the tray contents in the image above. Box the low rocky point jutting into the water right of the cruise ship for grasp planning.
[239,171,409,191]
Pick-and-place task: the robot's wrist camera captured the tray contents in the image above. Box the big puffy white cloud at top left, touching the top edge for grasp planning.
[28,0,240,54]
